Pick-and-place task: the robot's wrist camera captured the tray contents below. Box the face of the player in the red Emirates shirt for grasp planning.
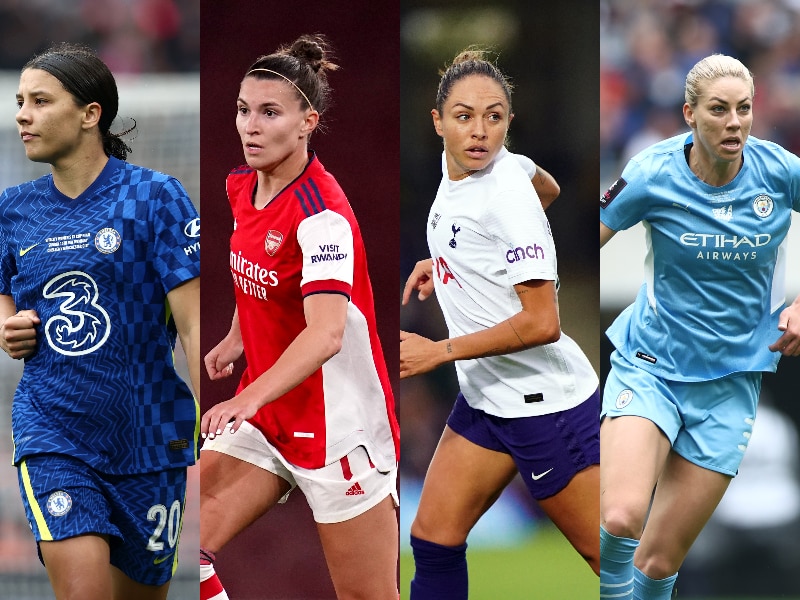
[236,77,316,172]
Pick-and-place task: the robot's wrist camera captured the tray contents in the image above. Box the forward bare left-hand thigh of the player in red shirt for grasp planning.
[200,448,292,553]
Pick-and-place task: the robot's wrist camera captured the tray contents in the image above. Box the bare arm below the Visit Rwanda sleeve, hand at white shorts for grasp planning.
[200,293,349,438]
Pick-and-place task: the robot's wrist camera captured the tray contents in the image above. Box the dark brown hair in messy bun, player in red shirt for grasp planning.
[245,34,339,115]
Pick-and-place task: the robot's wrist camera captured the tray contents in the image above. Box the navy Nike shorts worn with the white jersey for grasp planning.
[447,390,600,500]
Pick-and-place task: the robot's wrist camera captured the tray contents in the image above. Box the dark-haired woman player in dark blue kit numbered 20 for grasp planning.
[0,44,200,600]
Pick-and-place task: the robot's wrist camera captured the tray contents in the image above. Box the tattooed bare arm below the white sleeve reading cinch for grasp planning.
[400,280,561,378]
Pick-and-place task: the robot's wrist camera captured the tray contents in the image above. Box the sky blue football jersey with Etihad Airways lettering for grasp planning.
[600,134,800,381]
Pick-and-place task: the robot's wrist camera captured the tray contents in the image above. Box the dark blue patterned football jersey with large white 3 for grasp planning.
[0,157,200,474]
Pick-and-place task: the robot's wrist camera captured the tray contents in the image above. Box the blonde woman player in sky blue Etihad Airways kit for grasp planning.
[600,54,800,600]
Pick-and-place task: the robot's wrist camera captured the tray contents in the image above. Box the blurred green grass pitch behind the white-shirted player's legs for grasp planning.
[400,526,599,600]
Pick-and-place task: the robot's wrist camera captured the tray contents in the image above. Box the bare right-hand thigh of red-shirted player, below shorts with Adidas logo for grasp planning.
[317,496,399,600]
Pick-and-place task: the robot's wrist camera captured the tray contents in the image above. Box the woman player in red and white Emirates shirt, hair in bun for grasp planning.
[200,36,398,600]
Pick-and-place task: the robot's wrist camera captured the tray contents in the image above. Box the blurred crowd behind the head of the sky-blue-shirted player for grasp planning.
[600,0,800,189]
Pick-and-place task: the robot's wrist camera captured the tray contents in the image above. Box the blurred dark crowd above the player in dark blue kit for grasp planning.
[0,0,200,73]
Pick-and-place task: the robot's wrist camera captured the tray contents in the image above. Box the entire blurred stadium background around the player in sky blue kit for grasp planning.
[599,0,800,599]
